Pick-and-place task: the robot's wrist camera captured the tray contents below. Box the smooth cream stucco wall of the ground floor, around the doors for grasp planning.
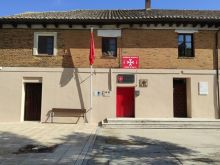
[0,68,217,123]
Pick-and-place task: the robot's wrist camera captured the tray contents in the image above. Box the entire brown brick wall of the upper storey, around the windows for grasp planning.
[0,29,215,69]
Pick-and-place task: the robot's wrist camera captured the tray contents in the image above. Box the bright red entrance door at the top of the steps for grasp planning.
[116,87,134,117]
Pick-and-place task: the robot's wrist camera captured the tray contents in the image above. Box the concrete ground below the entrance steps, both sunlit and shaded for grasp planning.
[84,129,220,165]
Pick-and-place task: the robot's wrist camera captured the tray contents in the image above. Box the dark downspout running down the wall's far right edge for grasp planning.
[215,30,220,118]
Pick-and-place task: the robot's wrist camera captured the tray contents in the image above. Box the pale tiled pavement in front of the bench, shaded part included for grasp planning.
[0,122,97,165]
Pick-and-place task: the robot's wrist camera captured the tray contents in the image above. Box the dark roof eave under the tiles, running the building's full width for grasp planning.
[0,18,220,25]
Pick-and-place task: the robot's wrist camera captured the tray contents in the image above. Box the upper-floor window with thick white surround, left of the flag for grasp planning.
[33,32,57,55]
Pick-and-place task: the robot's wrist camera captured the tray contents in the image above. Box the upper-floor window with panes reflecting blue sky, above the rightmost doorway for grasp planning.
[178,34,194,57]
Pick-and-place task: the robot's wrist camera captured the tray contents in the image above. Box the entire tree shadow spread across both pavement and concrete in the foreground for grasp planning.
[0,129,220,165]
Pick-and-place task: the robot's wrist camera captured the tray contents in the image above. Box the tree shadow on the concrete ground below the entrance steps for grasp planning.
[84,130,220,165]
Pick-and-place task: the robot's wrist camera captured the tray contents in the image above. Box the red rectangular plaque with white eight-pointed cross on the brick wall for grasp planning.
[122,56,139,69]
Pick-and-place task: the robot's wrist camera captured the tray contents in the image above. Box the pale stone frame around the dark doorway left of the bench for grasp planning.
[20,77,43,122]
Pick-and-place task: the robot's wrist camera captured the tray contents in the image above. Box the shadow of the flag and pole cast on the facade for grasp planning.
[60,49,88,122]
